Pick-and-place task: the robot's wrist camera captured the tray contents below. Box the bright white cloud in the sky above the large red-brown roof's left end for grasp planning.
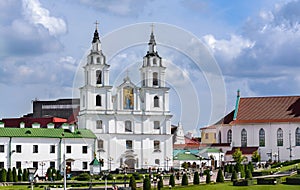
[203,34,255,60]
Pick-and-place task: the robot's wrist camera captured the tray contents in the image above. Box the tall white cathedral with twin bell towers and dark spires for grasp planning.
[78,27,173,170]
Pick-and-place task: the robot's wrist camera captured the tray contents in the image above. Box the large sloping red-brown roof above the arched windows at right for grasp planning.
[233,96,300,123]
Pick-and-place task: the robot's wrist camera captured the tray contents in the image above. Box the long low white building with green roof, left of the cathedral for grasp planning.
[0,123,96,177]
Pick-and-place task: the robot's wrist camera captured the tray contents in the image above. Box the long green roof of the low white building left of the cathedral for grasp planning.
[0,127,97,138]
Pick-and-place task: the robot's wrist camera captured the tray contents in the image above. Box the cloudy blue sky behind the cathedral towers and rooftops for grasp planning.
[0,0,300,137]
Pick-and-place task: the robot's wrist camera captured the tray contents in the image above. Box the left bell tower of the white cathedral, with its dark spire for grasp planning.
[79,22,113,128]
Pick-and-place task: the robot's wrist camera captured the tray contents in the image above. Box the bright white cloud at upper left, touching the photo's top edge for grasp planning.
[23,0,67,35]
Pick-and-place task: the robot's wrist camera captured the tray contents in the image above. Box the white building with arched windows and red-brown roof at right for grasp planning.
[216,91,300,161]
